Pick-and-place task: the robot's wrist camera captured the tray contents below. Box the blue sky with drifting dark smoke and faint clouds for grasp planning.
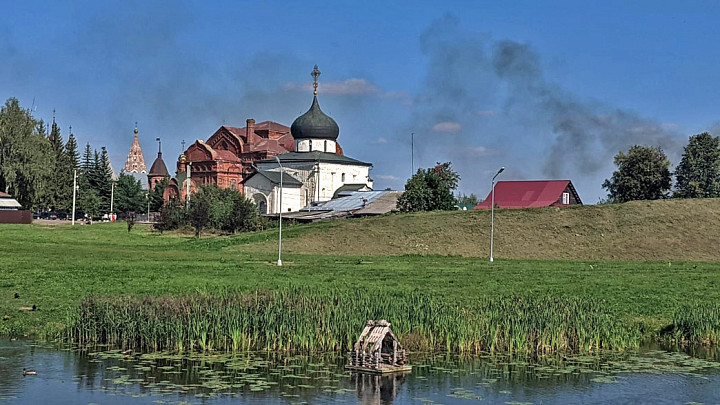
[0,1,720,203]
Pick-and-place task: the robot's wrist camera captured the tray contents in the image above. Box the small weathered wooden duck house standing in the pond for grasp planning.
[346,319,412,374]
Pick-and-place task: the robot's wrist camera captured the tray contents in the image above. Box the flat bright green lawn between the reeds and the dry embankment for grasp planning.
[0,219,720,337]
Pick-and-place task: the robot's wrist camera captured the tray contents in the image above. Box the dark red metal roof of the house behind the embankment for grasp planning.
[473,180,580,210]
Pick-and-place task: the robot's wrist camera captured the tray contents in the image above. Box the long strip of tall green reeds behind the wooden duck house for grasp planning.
[67,288,641,354]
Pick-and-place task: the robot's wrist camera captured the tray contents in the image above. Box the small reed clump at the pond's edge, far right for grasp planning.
[661,302,720,346]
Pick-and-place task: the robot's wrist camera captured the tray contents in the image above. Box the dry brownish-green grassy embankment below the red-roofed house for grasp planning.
[242,199,720,262]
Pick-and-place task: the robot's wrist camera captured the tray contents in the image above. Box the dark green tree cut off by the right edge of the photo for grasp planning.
[673,132,720,198]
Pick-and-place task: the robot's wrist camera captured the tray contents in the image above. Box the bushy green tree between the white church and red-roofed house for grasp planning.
[397,162,460,212]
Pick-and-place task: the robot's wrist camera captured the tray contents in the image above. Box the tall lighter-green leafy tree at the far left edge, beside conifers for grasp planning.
[0,98,54,209]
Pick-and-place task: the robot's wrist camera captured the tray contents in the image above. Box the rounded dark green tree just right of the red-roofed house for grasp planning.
[602,145,672,202]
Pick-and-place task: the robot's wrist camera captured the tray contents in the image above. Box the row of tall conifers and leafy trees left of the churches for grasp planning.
[0,98,152,217]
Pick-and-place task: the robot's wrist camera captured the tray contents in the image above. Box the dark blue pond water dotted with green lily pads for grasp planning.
[0,340,720,405]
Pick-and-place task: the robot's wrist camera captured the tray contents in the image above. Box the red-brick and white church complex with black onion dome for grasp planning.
[164,66,373,214]
